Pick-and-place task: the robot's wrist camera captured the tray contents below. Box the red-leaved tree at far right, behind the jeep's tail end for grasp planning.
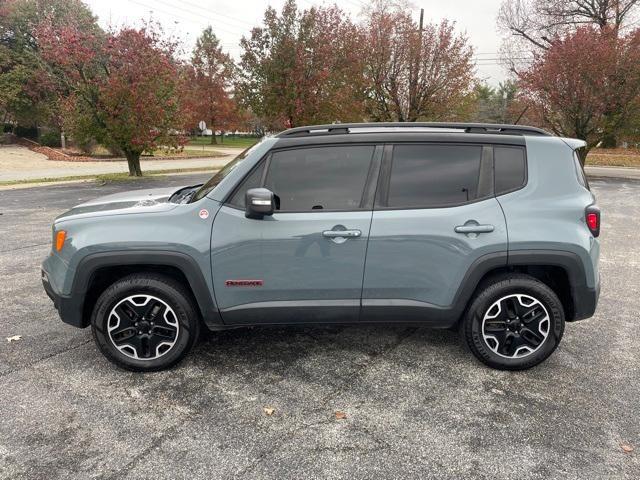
[520,26,640,161]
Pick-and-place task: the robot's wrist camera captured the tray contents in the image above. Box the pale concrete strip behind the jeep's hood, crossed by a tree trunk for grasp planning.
[0,145,242,182]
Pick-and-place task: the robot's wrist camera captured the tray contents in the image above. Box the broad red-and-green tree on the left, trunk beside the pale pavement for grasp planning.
[37,21,182,176]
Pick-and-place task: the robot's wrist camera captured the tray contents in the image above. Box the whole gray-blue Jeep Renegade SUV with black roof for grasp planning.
[42,123,600,371]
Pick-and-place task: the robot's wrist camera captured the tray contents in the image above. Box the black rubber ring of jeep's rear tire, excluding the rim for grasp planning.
[465,278,564,370]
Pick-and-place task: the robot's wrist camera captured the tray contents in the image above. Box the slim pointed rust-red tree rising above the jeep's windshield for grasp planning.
[183,27,242,144]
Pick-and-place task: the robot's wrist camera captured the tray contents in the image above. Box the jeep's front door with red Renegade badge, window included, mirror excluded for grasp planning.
[212,141,381,324]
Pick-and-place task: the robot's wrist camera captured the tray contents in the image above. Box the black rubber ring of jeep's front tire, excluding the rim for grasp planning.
[91,277,197,371]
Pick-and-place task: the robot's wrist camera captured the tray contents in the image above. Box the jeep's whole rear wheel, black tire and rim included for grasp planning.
[460,273,565,370]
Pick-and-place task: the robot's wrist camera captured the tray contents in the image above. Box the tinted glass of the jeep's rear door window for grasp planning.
[387,145,482,208]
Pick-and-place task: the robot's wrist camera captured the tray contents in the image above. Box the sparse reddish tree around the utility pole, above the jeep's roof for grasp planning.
[363,1,474,122]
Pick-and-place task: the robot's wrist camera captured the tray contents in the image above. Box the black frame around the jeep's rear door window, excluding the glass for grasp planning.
[374,142,494,210]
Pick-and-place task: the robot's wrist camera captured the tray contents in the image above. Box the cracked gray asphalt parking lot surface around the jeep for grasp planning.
[0,175,640,479]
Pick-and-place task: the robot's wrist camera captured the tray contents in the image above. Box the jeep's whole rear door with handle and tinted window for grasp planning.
[362,143,507,322]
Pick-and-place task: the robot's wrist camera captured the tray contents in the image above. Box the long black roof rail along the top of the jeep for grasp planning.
[276,122,551,138]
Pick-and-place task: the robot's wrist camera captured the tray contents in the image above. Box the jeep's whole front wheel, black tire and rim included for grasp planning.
[91,274,200,372]
